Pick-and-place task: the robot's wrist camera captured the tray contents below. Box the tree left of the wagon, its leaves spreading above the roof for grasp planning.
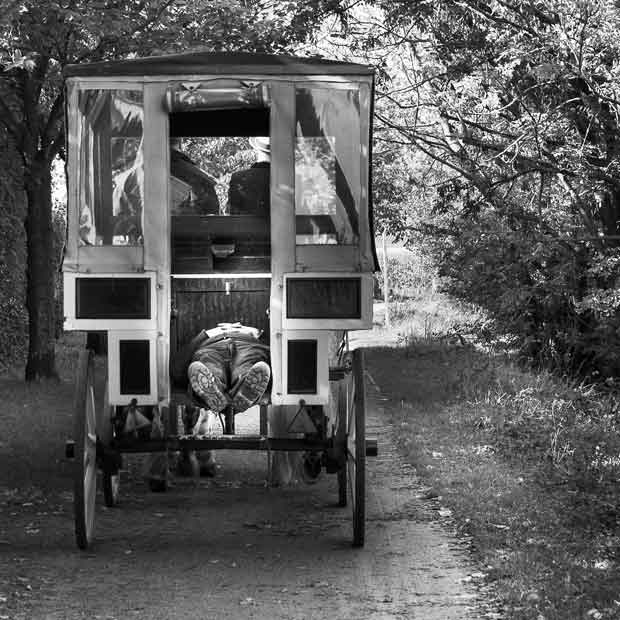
[0,0,340,378]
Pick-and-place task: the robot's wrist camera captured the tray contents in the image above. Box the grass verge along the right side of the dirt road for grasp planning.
[368,300,620,620]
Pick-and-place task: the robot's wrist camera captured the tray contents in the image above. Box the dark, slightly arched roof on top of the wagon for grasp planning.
[65,52,374,77]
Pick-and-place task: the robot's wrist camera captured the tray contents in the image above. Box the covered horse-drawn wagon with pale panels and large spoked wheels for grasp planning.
[63,53,376,548]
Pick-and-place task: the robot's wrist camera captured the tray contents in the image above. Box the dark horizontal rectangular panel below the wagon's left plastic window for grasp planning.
[75,278,151,319]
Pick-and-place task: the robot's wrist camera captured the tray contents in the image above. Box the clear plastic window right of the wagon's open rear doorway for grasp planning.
[295,87,361,245]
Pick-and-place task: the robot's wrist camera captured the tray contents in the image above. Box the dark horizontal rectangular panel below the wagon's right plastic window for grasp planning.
[286,278,362,319]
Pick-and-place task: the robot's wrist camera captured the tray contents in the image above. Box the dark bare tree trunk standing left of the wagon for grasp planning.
[25,153,58,381]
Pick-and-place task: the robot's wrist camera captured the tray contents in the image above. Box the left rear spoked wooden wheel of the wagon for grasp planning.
[73,349,97,549]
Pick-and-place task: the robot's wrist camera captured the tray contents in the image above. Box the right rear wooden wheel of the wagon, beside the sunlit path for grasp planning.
[336,349,366,547]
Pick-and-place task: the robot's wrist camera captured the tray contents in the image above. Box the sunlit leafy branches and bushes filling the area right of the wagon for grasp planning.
[317,0,620,376]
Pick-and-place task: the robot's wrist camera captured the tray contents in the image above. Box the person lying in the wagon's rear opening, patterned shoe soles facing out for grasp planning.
[179,323,271,413]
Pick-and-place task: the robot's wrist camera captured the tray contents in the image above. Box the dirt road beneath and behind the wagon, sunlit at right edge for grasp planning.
[0,353,494,620]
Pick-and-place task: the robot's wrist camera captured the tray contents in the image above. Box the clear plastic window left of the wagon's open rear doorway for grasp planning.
[78,89,144,246]
